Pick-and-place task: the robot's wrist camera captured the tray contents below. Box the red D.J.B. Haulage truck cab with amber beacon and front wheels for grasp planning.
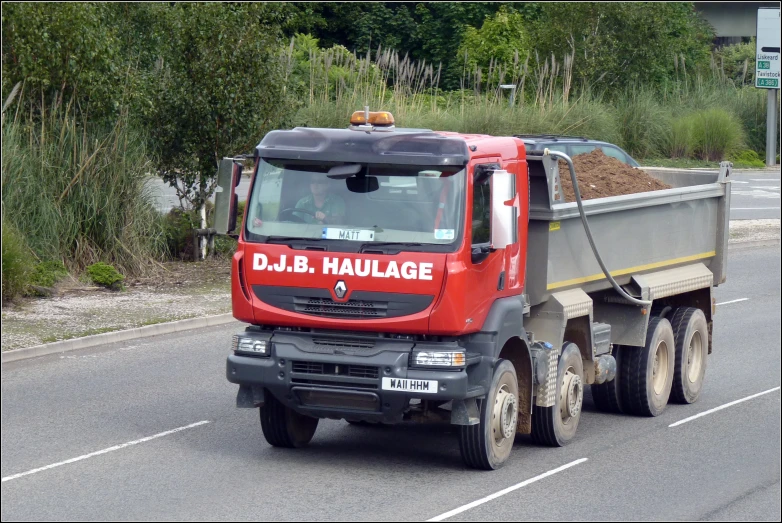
[227,113,544,468]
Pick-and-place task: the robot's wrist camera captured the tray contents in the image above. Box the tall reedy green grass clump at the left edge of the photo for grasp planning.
[2,93,164,274]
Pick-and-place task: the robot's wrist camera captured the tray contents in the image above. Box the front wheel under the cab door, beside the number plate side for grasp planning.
[459,360,519,470]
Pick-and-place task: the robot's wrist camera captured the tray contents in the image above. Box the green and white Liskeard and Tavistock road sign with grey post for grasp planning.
[755,7,782,167]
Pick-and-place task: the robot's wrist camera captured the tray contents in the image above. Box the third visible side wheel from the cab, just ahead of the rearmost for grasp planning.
[618,318,675,416]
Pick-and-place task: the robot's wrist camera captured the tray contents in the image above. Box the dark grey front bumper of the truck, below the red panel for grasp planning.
[226,332,489,423]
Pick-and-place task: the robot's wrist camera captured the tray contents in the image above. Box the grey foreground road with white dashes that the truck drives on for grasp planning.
[0,245,782,521]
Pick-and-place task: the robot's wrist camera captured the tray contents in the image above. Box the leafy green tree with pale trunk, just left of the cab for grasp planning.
[145,3,290,208]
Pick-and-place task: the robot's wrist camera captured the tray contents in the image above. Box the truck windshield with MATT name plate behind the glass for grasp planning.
[245,159,464,250]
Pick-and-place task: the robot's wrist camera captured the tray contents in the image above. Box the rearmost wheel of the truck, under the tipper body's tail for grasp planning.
[671,307,709,403]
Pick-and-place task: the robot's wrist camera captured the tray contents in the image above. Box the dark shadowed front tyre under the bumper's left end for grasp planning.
[260,392,318,449]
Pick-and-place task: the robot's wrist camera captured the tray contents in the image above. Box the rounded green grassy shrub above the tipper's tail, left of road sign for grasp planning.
[692,109,743,161]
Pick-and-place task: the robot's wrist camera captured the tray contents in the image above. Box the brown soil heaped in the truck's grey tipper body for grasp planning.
[559,149,671,202]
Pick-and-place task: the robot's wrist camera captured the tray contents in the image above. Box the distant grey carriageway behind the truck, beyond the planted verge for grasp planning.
[149,171,780,220]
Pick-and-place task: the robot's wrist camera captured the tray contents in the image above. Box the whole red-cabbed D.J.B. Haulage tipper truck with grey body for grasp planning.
[211,110,730,469]
